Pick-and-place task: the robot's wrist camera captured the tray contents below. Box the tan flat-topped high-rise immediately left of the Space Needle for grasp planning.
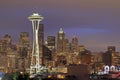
[17,32,31,71]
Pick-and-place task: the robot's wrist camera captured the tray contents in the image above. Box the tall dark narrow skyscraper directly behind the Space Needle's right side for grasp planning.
[38,24,44,64]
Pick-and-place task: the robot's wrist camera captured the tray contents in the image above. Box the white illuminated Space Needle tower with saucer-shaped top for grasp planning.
[28,13,43,74]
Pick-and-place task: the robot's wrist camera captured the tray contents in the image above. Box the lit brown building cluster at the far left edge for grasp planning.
[0,34,17,72]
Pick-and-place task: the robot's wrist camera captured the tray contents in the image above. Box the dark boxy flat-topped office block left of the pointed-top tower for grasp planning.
[47,36,55,52]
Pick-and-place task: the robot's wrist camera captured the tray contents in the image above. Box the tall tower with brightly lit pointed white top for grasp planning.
[57,28,65,53]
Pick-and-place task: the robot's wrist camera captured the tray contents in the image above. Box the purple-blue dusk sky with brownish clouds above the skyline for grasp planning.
[0,0,120,51]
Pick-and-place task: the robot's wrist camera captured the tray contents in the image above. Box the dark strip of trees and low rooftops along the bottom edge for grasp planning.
[2,72,120,80]
